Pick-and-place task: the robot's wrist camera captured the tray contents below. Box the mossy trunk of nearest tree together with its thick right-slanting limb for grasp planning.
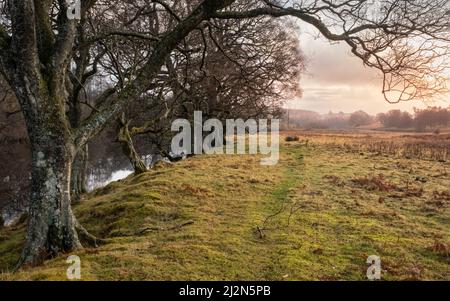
[0,0,234,266]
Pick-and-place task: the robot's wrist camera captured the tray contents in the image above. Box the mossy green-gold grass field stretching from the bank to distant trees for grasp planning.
[0,132,450,280]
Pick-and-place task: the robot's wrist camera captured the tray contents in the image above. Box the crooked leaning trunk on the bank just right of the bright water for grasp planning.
[117,117,148,174]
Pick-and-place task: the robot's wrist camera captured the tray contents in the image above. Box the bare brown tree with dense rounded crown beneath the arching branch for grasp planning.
[111,4,304,173]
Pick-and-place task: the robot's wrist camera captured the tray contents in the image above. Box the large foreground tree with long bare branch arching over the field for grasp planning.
[0,0,449,264]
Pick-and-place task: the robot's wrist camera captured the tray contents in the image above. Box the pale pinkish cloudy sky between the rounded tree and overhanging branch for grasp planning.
[287,25,450,114]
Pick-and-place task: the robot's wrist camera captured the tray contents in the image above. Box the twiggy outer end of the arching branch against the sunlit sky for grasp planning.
[213,0,450,103]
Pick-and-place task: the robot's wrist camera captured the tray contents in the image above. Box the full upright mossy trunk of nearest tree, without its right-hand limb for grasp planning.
[1,0,81,266]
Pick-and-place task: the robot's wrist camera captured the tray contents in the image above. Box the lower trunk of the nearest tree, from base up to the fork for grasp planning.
[19,132,81,266]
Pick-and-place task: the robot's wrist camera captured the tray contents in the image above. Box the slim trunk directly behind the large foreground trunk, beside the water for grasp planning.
[71,145,88,202]
